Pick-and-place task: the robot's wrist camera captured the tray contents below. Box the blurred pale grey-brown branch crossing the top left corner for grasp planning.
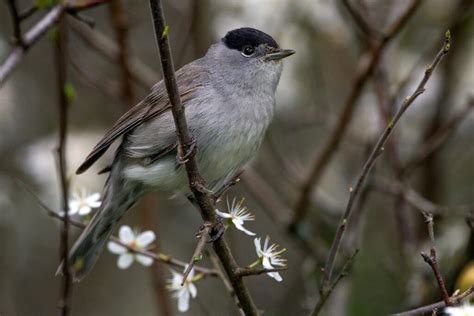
[0,0,107,87]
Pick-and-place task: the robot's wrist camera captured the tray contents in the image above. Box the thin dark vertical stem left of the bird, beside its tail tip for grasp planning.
[54,16,72,316]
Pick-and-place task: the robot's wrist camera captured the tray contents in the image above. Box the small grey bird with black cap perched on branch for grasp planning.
[65,27,295,281]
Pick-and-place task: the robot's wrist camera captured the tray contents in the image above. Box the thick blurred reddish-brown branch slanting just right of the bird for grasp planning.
[289,0,422,231]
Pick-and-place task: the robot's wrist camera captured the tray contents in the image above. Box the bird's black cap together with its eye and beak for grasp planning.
[222,27,295,61]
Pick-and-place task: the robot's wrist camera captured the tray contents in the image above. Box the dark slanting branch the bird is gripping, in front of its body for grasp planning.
[150,0,259,315]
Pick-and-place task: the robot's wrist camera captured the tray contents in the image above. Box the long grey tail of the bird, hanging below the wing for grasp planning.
[58,170,140,282]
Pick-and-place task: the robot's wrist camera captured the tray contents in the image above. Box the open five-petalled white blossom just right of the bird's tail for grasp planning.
[107,226,156,269]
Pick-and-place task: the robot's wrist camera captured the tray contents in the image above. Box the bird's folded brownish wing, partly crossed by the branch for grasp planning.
[76,62,208,174]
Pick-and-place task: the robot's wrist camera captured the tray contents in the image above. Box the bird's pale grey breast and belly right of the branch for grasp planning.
[186,85,274,190]
